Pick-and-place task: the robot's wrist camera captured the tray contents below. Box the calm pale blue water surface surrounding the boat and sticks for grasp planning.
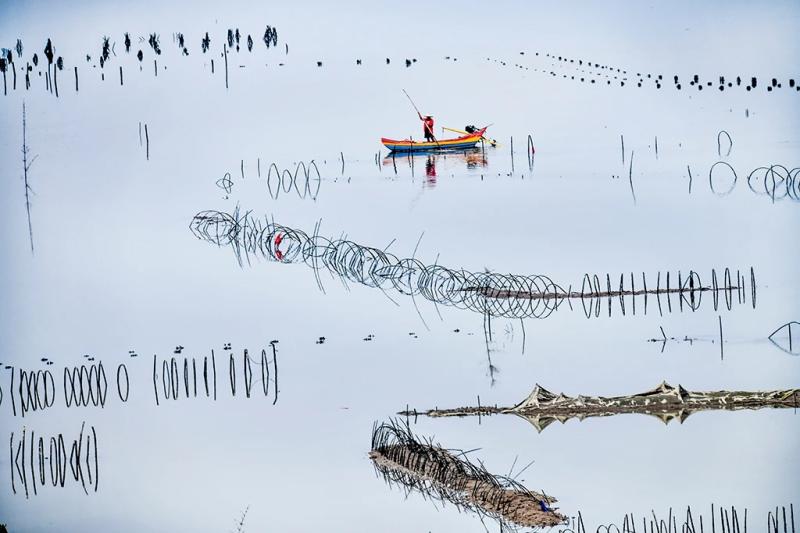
[0,3,800,532]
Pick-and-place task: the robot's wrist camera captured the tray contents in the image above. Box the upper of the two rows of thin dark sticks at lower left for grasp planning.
[0,348,279,418]
